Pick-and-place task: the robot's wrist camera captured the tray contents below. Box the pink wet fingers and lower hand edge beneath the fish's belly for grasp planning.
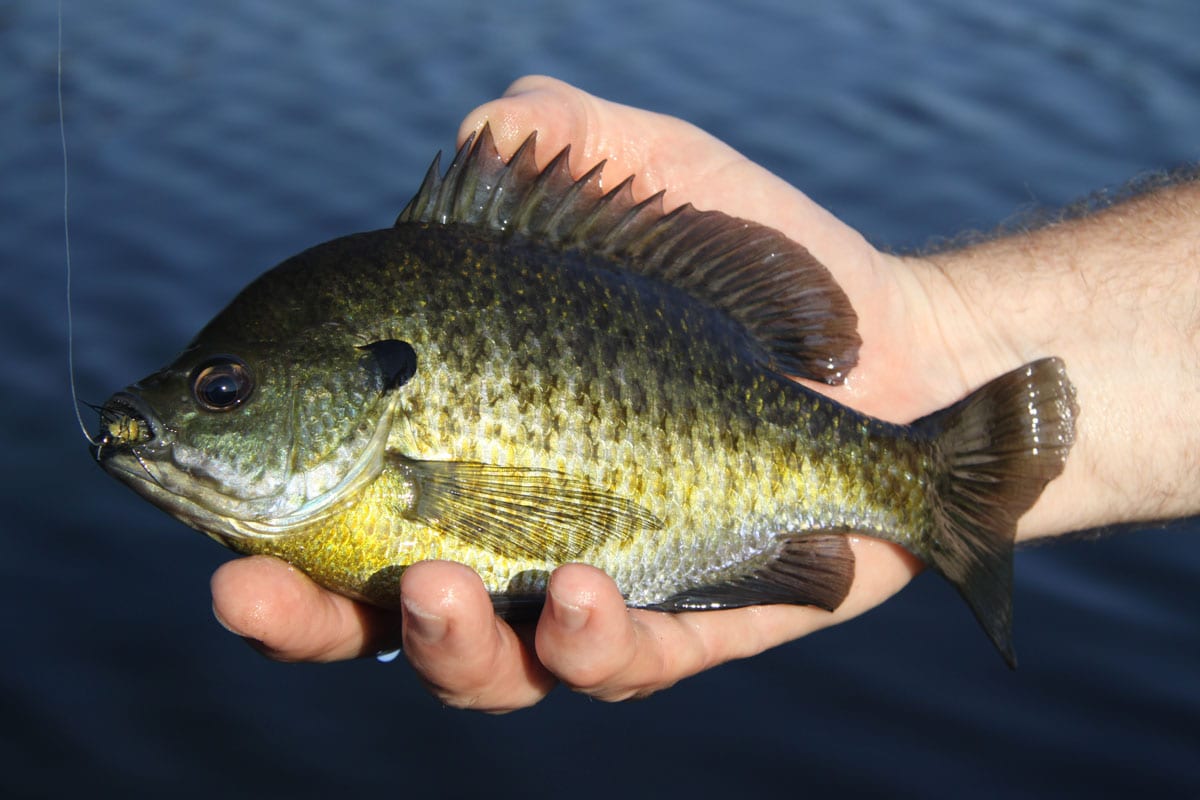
[212,537,919,712]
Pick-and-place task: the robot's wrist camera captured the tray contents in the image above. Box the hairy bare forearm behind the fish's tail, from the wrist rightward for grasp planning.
[914,175,1200,539]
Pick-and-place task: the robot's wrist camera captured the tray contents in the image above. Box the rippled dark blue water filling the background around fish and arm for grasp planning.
[0,0,1200,798]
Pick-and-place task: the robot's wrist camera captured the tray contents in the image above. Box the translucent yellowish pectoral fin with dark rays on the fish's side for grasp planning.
[392,456,662,561]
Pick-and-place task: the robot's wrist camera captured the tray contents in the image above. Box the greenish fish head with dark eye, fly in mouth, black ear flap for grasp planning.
[94,318,416,549]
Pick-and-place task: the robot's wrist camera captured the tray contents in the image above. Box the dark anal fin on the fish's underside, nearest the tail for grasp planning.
[650,533,854,612]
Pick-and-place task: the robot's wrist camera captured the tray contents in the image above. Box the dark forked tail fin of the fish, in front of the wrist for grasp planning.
[913,359,1078,667]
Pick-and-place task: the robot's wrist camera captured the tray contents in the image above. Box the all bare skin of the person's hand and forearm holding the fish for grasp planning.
[212,77,1200,711]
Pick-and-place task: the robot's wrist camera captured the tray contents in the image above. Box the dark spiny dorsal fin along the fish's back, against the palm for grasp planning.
[396,125,862,384]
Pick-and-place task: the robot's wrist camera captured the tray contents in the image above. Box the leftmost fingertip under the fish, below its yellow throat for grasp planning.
[211,555,400,661]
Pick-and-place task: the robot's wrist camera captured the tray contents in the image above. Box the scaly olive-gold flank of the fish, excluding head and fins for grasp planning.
[223,221,929,592]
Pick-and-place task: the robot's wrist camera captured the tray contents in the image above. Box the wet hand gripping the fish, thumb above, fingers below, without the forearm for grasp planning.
[212,78,1195,711]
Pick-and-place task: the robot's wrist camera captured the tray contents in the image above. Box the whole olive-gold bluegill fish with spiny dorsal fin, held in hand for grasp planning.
[92,126,1078,666]
